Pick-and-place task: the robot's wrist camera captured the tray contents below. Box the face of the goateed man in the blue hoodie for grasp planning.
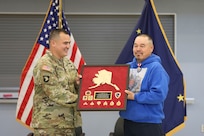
[133,36,154,63]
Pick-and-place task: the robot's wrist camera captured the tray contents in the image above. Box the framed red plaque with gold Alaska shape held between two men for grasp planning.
[77,65,129,111]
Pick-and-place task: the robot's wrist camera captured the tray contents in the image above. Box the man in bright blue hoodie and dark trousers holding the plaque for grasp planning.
[120,34,169,136]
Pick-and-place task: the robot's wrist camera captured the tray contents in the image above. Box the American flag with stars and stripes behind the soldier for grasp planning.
[16,0,85,127]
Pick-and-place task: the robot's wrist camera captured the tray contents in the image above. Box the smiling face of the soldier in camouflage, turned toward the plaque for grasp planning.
[53,33,71,59]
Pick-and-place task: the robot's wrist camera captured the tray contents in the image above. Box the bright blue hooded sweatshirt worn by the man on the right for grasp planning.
[119,54,169,123]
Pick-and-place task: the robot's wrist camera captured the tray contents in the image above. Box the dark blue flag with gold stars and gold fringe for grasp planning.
[116,0,186,136]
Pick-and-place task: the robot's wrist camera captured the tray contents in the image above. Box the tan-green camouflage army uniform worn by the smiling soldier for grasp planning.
[32,51,82,135]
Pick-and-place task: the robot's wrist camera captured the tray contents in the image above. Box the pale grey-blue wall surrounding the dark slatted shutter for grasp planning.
[0,0,204,136]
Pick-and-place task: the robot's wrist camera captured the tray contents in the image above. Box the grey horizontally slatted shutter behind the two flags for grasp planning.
[0,14,174,87]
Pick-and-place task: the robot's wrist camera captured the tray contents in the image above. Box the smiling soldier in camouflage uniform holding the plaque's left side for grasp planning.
[32,29,82,136]
